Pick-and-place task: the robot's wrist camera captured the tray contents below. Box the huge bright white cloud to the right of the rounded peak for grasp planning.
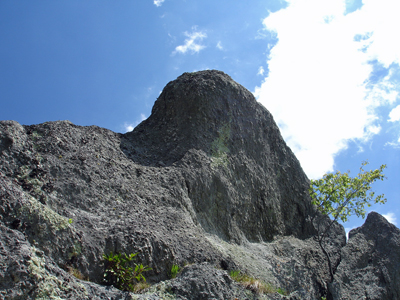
[255,0,400,178]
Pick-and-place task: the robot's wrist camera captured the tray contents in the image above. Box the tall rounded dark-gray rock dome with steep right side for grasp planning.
[122,71,312,243]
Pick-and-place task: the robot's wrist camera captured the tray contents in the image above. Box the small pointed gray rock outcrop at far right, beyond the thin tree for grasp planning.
[331,212,400,300]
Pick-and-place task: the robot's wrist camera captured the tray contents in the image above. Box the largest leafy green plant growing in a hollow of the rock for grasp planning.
[103,252,151,292]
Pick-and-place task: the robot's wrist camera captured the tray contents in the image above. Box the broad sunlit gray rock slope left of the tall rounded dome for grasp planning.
[0,118,225,283]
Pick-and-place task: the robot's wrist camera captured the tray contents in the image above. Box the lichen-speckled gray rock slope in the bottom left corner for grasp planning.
[0,199,132,300]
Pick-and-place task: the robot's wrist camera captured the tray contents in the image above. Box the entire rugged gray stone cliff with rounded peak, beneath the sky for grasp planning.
[0,71,400,299]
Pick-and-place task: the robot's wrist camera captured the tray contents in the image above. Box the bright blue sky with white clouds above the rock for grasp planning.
[0,0,400,228]
